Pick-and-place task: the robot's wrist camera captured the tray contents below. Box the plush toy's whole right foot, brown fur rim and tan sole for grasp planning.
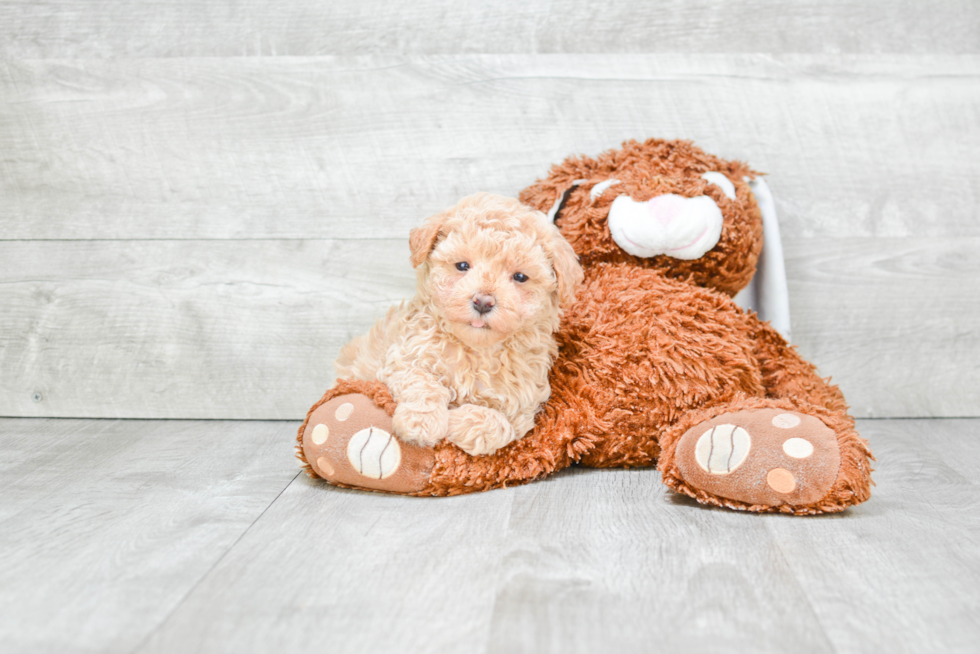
[659,396,871,515]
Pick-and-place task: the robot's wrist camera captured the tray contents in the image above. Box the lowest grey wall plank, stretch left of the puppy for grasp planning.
[0,240,415,419]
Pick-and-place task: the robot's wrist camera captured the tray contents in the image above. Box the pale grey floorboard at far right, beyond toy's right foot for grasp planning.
[767,420,980,652]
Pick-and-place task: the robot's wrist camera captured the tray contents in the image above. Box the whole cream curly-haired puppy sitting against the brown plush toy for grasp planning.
[335,193,582,454]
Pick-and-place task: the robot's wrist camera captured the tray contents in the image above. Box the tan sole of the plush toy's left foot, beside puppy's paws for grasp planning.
[303,393,435,493]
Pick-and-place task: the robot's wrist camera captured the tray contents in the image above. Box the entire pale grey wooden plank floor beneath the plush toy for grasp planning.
[0,418,980,653]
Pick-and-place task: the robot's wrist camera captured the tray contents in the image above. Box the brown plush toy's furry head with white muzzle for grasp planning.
[520,139,762,295]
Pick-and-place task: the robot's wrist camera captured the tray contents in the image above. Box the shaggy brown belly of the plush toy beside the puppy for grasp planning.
[552,269,765,466]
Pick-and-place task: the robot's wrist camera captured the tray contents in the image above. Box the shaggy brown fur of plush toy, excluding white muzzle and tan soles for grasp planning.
[420,139,873,515]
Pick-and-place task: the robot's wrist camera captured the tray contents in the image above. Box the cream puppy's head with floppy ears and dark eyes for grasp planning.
[412,194,582,347]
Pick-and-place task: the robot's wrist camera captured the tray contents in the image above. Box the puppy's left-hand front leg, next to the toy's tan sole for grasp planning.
[387,371,449,447]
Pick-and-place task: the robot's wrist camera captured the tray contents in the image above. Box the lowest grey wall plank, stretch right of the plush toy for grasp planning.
[784,237,980,417]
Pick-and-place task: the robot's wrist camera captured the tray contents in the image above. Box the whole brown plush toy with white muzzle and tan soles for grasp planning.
[297,139,872,514]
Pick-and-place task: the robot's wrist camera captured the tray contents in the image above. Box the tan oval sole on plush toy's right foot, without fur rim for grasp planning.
[675,409,840,506]
